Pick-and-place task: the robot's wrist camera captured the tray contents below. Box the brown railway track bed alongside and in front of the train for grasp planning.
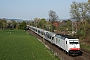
[28,30,90,60]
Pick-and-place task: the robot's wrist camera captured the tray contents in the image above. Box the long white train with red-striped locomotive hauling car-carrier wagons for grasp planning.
[28,25,82,56]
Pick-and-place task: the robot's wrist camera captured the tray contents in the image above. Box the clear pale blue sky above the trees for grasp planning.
[0,0,88,20]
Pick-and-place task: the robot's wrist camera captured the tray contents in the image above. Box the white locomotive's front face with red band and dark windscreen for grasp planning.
[68,39,81,55]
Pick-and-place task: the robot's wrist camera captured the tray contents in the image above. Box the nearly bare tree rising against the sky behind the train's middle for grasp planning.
[49,10,58,32]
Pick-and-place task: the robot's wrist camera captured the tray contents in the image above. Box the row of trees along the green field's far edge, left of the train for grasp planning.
[0,18,26,30]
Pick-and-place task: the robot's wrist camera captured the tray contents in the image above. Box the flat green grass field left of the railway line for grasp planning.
[0,30,56,60]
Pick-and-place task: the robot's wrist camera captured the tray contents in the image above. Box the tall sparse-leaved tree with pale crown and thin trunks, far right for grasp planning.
[70,1,90,32]
